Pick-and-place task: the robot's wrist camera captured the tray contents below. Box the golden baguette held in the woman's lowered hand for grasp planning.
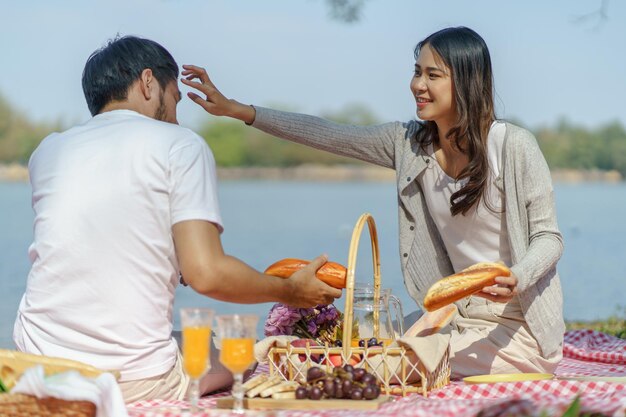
[424,262,511,311]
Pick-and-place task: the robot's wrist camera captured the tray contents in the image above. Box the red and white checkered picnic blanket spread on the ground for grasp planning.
[128,330,626,417]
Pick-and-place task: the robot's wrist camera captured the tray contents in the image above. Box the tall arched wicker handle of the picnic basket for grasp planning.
[342,213,380,360]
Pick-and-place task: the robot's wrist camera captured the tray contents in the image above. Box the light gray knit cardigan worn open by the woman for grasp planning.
[252,107,565,357]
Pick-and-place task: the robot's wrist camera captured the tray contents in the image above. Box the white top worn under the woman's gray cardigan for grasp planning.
[417,121,511,272]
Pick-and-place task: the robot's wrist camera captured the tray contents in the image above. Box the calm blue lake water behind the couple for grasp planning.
[0,181,626,348]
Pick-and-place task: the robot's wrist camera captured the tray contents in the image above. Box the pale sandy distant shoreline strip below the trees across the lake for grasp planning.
[0,163,624,183]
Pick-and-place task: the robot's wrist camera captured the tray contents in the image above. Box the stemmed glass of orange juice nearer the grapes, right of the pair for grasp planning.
[216,314,259,414]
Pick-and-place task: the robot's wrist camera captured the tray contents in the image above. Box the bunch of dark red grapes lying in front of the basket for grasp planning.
[296,365,380,400]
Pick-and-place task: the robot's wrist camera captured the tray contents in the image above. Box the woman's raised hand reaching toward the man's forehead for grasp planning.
[181,65,256,124]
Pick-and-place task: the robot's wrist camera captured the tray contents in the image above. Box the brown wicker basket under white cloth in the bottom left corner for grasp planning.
[0,394,96,417]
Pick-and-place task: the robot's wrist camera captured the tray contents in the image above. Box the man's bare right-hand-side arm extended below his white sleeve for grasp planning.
[172,220,341,307]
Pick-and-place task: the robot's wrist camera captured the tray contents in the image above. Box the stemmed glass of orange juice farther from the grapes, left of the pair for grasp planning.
[180,308,215,413]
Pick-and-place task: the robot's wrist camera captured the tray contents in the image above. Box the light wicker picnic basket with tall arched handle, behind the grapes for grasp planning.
[268,213,450,396]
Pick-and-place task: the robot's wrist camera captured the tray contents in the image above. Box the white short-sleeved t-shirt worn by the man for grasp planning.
[13,110,222,380]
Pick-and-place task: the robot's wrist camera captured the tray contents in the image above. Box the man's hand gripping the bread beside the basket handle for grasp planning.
[284,255,341,307]
